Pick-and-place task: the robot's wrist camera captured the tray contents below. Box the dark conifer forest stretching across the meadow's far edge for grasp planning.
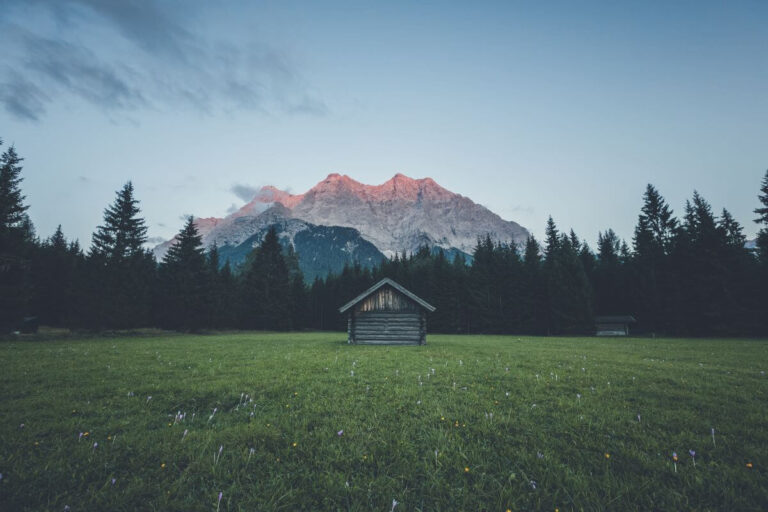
[0,137,768,336]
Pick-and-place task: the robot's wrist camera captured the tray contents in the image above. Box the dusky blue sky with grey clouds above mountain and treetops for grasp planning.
[0,0,768,247]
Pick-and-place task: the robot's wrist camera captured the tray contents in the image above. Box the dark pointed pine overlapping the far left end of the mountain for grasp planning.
[159,217,210,331]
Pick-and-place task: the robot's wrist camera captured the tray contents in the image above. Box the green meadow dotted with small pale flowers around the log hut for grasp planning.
[0,333,768,512]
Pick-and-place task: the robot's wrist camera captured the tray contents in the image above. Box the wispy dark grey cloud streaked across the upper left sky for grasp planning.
[0,0,328,121]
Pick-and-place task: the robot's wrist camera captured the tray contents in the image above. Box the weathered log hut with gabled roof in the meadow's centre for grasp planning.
[339,278,435,345]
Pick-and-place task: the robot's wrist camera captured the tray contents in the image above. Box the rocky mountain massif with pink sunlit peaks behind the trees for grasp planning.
[155,173,528,275]
